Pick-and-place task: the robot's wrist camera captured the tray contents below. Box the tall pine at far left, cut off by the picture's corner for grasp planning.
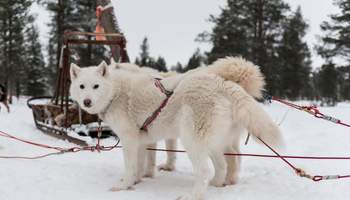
[0,0,32,97]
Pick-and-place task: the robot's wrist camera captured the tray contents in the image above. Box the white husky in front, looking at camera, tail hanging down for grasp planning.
[70,58,281,200]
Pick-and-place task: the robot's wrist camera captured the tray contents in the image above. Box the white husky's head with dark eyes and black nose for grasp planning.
[70,61,117,114]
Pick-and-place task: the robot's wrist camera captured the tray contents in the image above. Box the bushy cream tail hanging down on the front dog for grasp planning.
[224,81,282,147]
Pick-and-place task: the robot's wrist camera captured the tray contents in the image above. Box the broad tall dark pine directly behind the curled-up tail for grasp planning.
[201,0,289,93]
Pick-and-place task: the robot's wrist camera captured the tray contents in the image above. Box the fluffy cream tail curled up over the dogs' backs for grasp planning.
[206,57,265,98]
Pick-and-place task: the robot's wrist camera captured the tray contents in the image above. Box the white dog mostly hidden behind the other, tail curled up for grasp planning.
[110,57,265,177]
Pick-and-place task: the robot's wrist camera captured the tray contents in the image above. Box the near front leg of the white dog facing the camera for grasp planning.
[110,138,139,191]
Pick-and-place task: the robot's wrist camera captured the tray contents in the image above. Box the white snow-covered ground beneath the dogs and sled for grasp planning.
[0,101,350,200]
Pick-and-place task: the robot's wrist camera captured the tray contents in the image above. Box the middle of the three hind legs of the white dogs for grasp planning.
[210,150,227,187]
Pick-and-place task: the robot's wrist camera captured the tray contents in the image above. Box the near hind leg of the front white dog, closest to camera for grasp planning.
[178,135,209,200]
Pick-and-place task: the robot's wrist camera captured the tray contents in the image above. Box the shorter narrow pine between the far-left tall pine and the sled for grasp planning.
[25,24,47,96]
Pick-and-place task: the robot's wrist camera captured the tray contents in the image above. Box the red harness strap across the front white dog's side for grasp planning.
[140,78,173,131]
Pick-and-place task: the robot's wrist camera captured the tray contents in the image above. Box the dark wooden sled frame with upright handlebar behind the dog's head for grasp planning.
[30,32,129,146]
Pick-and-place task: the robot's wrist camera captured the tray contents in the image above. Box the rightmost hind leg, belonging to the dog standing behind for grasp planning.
[225,146,241,185]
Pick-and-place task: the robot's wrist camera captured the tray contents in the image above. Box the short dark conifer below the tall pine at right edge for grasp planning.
[318,62,338,106]
